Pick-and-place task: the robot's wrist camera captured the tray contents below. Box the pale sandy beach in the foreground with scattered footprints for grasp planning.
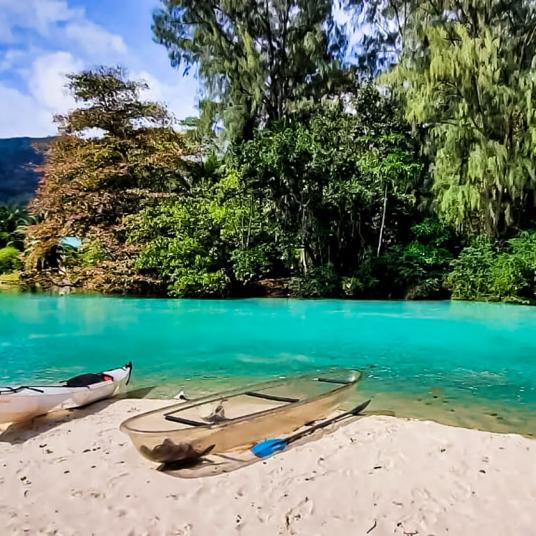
[0,400,536,536]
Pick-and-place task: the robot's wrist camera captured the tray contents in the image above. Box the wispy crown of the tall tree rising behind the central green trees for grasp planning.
[153,0,361,138]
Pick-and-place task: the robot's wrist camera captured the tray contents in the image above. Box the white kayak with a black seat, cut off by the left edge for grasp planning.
[0,363,132,423]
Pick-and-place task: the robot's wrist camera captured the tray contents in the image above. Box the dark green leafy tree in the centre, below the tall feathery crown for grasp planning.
[236,86,422,275]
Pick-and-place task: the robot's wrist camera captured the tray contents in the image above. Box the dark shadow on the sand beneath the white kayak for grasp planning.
[0,385,156,445]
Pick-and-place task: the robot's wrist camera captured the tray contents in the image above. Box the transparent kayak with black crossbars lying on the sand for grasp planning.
[121,372,360,463]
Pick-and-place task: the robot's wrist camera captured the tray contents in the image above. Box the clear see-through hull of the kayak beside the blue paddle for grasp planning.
[121,372,358,463]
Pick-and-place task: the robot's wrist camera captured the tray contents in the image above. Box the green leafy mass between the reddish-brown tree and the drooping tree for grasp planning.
[119,87,422,296]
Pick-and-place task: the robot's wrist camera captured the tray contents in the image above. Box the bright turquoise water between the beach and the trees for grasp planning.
[0,294,536,430]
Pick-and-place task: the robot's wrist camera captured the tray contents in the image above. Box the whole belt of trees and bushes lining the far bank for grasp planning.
[15,0,536,303]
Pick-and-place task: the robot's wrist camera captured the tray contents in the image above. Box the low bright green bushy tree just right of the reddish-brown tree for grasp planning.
[128,169,277,297]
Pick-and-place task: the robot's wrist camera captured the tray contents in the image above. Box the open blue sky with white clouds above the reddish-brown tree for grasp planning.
[0,0,198,138]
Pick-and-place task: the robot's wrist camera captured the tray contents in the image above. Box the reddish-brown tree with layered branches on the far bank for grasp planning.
[25,67,195,292]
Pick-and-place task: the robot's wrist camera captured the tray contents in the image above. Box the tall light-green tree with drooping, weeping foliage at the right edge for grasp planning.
[386,0,536,236]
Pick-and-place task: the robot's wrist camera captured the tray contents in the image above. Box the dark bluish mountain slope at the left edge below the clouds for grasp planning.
[0,137,54,203]
